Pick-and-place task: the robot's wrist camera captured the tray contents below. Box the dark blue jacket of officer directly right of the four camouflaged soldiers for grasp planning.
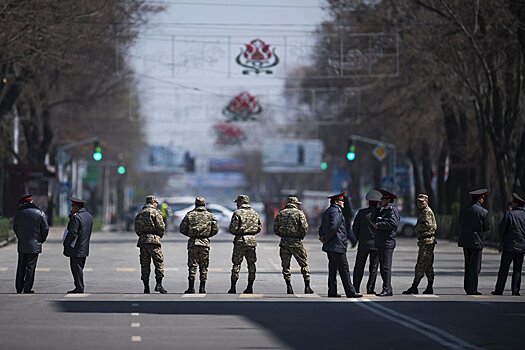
[319,204,355,253]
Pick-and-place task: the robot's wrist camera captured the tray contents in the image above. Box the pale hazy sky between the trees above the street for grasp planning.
[129,0,326,153]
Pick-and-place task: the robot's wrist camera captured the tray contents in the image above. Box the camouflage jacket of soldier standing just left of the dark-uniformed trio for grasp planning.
[273,203,308,248]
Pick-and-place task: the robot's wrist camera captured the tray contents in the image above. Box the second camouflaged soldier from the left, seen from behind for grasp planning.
[180,197,219,294]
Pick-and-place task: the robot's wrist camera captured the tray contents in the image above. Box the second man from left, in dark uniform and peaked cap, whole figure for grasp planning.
[63,198,93,294]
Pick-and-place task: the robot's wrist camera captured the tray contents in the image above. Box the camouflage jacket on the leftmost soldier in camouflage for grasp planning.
[135,203,166,247]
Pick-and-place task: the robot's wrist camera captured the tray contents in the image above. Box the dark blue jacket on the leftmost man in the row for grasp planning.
[13,202,49,254]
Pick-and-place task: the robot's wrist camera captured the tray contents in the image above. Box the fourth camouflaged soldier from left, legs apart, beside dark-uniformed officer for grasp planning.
[273,196,314,294]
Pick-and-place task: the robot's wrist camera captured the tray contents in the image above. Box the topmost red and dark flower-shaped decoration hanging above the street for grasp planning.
[235,39,279,74]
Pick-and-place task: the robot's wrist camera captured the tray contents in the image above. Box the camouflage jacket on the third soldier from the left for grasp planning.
[230,204,262,247]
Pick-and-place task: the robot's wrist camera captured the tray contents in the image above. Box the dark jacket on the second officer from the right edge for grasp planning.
[458,202,490,249]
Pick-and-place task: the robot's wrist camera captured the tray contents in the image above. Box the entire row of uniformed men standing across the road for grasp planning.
[13,189,525,297]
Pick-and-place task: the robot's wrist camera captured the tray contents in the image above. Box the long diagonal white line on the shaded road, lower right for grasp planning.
[355,299,483,350]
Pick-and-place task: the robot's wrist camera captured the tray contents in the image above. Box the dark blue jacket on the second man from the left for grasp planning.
[63,208,93,258]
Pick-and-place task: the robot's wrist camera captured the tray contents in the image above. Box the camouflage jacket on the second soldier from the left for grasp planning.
[180,206,219,249]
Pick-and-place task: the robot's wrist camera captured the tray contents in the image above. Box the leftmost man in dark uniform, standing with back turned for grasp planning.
[13,194,49,293]
